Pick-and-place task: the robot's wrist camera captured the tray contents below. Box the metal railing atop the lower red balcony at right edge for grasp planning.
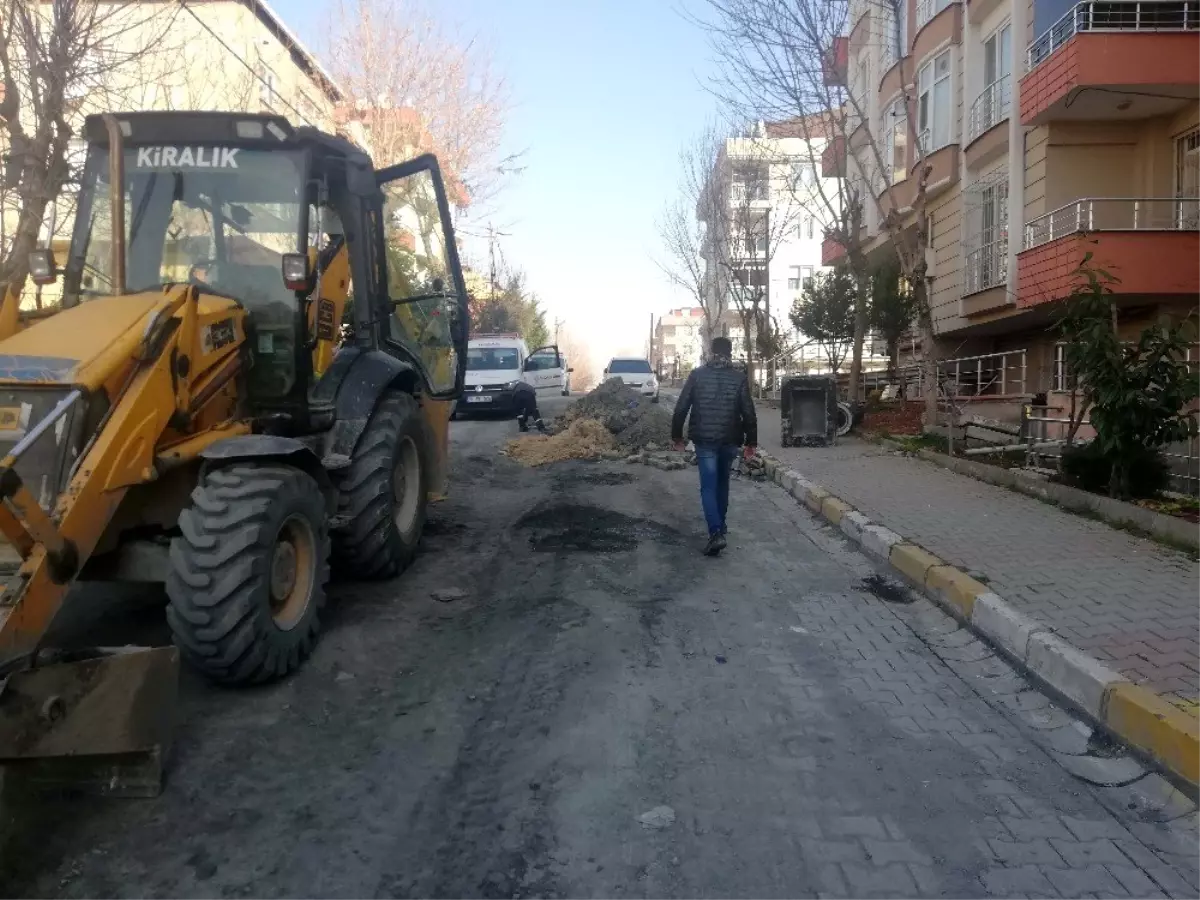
[1022,197,1200,250]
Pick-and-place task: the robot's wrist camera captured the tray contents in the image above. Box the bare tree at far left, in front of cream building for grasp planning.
[0,0,179,284]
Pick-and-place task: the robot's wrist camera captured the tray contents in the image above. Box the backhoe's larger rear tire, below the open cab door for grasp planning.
[331,390,428,580]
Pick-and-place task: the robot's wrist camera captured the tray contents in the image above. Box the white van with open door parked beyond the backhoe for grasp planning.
[455,334,570,415]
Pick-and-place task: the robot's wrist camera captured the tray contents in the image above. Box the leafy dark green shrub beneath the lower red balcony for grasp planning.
[1057,253,1200,498]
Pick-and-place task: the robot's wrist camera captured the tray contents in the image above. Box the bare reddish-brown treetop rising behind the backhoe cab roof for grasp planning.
[328,0,517,209]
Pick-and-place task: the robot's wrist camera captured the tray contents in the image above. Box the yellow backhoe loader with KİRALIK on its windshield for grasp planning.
[0,113,468,796]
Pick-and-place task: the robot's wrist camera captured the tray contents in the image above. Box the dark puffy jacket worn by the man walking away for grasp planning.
[671,360,758,446]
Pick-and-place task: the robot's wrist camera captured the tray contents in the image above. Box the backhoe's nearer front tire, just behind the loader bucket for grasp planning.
[167,462,330,684]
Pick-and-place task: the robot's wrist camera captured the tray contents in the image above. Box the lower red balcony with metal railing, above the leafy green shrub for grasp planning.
[1016,197,1200,307]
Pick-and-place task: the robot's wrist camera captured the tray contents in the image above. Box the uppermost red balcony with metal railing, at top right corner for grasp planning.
[1020,0,1200,126]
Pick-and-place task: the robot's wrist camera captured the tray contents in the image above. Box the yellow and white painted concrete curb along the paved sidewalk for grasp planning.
[763,454,1200,788]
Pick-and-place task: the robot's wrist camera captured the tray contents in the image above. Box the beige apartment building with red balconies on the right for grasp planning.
[824,0,1200,420]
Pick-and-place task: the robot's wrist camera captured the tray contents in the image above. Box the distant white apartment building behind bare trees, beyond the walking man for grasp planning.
[697,116,839,374]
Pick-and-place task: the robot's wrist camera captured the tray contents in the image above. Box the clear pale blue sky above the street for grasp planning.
[271,0,716,364]
